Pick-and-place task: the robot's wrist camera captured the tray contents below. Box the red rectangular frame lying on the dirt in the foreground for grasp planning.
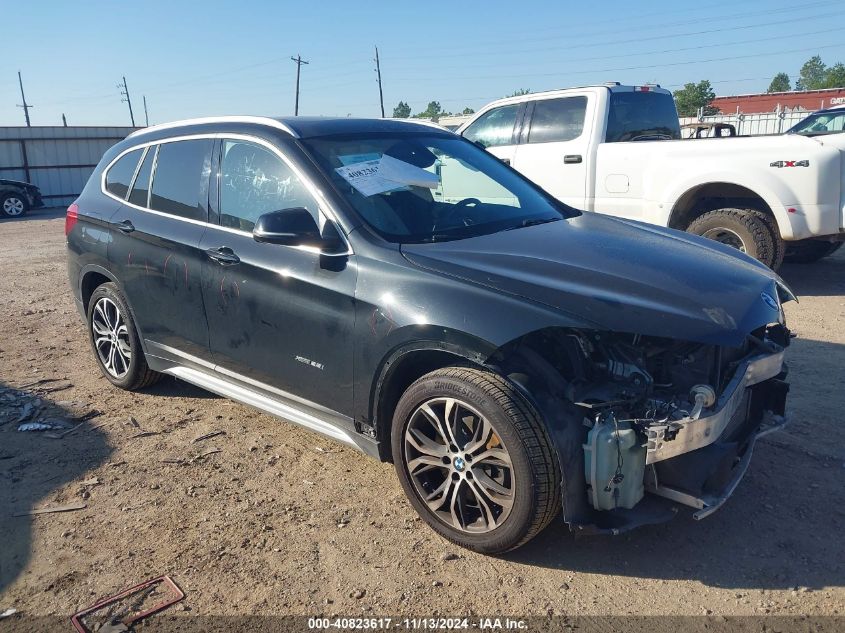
[70,576,185,633]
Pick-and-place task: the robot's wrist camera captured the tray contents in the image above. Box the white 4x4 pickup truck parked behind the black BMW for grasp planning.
[454,83,845,269]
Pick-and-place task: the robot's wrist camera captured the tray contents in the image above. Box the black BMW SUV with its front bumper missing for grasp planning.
[65,117,794,553]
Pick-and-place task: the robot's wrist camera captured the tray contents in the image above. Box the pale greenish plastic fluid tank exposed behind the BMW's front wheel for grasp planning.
[584,417,646,510]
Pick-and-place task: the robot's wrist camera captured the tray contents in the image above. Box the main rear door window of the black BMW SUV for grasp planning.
[150,139,214,220]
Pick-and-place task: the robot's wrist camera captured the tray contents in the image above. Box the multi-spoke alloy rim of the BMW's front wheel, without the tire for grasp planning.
[404,398,515,533]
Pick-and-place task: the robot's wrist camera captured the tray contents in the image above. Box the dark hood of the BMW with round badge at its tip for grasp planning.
[402,213,794,346]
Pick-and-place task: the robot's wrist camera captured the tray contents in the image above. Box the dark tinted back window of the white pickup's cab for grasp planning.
[605,91,681,143]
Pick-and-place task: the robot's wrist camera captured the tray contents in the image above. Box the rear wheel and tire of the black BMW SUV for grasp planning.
[88,282,161,391]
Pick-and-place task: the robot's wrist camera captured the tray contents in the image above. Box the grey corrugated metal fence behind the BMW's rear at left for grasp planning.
[0,127,137,206]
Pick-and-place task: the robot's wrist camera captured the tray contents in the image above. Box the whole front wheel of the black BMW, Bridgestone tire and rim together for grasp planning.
[391,367,561,554]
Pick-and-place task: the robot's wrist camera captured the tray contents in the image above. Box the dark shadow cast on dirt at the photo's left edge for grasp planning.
[0,382,112,593]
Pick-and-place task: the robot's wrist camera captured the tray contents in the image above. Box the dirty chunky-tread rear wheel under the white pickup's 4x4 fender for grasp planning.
[687,209,776,268]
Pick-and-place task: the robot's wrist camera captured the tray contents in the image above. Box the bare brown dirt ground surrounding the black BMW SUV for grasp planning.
[0,209,845,631]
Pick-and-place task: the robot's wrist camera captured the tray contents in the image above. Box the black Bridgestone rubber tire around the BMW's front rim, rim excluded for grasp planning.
[391,367,561,554]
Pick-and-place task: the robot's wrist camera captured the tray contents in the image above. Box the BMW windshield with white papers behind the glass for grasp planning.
[302,132,577,243]
